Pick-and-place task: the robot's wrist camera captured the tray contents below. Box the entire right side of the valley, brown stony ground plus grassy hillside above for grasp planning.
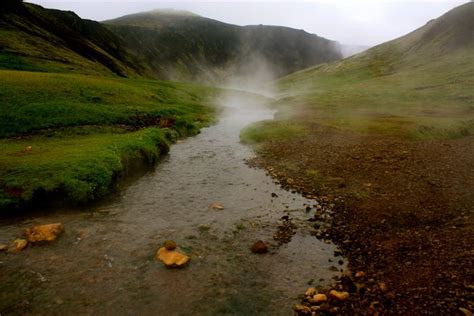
[241,2,474,315]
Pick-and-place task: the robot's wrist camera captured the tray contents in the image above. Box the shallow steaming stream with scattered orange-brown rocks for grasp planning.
[0,93,337,315]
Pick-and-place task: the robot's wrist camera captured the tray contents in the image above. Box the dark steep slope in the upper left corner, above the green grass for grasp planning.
[0,0,146,77]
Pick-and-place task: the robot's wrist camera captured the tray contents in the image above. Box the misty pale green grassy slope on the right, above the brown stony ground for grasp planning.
[246,3,474,140]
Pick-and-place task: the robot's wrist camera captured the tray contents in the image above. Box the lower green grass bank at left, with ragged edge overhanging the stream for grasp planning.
[0,128,169,212]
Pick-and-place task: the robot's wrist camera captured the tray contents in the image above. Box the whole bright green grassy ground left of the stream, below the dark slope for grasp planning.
[0,70,217,213]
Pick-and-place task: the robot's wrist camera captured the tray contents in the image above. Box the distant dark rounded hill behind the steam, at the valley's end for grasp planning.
[104,11,341,81]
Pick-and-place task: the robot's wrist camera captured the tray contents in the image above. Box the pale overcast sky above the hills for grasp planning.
[25,0,467,46]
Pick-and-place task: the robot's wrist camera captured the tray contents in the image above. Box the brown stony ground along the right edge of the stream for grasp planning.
[250,125,474,315]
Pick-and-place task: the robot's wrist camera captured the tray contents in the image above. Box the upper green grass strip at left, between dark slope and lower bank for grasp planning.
[0,70,218,138]
